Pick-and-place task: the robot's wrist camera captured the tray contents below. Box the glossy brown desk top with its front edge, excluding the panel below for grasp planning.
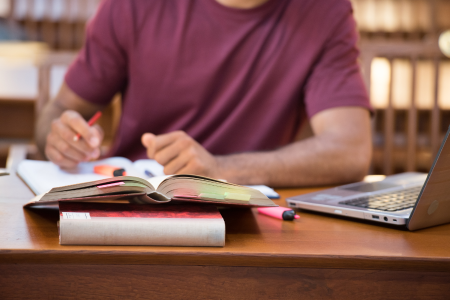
[0,175,450,272]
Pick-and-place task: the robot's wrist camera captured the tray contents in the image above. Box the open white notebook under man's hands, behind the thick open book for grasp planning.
[17,157,279,199]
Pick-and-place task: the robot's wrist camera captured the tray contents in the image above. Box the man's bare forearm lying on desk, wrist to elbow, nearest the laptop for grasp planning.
[216,132,371,187]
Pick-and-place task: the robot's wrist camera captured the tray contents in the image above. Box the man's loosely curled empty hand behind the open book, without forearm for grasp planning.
[142,131,220,178]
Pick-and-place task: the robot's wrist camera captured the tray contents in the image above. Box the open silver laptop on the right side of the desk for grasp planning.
[286,127,450,230]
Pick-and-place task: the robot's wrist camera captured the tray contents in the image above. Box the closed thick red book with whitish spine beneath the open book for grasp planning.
[58,202,225,246]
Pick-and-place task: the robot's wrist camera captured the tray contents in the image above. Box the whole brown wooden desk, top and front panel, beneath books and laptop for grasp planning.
[0,176,450,299]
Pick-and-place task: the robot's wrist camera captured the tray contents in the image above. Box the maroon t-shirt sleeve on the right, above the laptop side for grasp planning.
[304,4,371,117]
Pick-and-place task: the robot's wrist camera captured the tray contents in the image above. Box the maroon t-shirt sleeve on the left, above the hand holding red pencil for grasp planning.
[65,0,127,105]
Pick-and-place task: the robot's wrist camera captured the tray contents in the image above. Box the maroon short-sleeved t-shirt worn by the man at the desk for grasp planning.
[65,0,370,160]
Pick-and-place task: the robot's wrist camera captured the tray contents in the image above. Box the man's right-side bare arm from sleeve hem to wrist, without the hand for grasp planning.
[217,107,372,187]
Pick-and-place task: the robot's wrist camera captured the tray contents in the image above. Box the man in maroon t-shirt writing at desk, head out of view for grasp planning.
[37,0,371,186]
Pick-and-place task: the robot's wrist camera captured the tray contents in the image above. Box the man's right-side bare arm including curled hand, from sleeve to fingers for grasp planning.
[142,107,372,187]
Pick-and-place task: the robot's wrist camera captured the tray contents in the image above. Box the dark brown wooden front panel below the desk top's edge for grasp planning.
[0,265,450,299]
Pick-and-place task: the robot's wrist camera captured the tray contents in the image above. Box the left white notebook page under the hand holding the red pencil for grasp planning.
[17,157,143,195]
